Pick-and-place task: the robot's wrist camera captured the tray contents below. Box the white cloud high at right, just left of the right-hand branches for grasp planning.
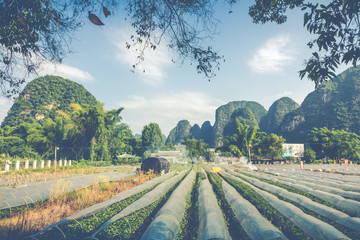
[248,35,295,74]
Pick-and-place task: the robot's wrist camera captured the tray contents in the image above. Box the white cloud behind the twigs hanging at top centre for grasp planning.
[111,29,171,86]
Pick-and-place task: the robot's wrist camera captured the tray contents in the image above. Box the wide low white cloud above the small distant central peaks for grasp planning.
[117,92,224,135]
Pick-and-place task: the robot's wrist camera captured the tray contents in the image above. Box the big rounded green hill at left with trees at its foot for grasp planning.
[0,76,165,162]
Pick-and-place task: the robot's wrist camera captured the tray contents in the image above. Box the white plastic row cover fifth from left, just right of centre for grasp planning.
[222,174,287,240]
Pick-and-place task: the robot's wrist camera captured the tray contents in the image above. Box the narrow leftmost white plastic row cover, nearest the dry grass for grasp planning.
[30,172,175,238]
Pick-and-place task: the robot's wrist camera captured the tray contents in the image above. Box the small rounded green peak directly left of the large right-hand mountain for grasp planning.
[260,97,300,133]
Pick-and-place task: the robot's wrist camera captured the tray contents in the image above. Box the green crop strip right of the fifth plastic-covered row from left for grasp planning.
[220,174,310,240]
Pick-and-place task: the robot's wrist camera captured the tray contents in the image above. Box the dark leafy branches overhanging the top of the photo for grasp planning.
[0,0,360,96]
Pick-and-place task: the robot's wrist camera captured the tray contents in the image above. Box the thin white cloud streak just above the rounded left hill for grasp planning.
[39,62,94,82]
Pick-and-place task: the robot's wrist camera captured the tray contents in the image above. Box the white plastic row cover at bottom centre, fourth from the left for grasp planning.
[198,178,231,240]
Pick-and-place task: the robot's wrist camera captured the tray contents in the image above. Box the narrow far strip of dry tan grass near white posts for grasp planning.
[0,166,134,186]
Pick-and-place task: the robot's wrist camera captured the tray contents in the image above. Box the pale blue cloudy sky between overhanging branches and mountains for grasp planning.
[0,1,352,135]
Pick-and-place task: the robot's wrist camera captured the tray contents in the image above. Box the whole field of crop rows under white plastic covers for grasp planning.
[29,167,360,240]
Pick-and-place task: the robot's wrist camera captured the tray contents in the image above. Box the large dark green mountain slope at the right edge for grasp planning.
[279,67,360,142]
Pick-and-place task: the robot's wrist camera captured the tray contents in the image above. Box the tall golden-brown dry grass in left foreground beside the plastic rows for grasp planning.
[0,174,155,240]
